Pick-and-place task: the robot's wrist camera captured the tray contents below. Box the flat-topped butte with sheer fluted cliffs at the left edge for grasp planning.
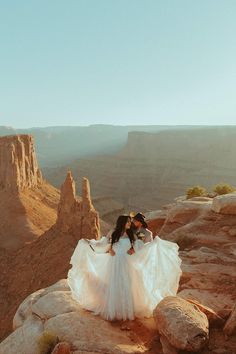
[0,135,42,192]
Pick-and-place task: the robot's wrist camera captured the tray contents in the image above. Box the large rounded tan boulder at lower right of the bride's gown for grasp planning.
[154,296,209,354]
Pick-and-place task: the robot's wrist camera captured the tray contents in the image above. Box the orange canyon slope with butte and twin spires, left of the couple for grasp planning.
[0,135,103,339]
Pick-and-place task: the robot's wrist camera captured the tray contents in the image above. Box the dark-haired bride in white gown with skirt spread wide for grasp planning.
[68,215,182,321]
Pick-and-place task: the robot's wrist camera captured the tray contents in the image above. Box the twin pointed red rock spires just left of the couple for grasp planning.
[56,171,100,239]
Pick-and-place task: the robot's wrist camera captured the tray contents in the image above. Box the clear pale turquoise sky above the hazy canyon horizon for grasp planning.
[0,0,236,128]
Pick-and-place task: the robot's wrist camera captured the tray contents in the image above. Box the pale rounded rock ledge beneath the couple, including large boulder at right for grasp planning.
[0,279,234,354]
